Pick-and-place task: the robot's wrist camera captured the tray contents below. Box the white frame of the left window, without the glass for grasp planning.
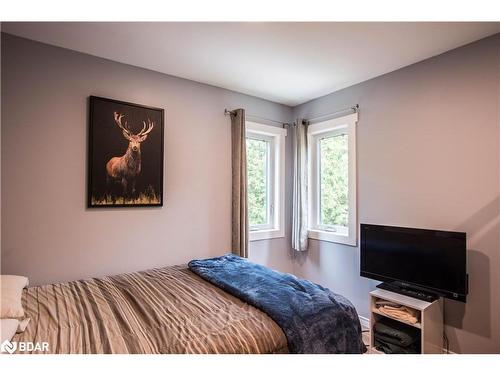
[246,121,286,241]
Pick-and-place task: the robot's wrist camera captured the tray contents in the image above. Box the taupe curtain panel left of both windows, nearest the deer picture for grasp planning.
[231,109,248,258]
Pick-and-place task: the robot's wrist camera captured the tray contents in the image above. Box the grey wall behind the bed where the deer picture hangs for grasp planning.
[1,34,291,285]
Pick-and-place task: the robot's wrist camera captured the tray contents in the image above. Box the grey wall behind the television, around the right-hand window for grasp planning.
[293,34,500,353]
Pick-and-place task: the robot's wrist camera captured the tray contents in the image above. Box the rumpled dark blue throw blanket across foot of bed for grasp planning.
[189,254,366,353]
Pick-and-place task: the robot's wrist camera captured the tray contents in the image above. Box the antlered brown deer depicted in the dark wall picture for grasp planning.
[106,112,154,197]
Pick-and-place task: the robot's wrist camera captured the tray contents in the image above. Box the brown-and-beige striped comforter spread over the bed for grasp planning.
[13,266,287,353]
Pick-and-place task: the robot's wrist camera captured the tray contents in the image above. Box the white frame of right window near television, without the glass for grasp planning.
[307,113,358,246]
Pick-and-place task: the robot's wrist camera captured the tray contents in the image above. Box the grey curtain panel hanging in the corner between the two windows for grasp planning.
[292,119,308,251]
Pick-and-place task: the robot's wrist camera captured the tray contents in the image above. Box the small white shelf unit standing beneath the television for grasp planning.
[370,289,443,354]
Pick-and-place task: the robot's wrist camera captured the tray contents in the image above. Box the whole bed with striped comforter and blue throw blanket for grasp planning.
[11,254,366,354]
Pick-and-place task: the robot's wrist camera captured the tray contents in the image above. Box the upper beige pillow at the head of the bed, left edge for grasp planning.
[0,275,28,319]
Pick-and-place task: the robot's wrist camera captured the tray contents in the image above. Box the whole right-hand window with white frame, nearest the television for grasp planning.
[307,113,358,246]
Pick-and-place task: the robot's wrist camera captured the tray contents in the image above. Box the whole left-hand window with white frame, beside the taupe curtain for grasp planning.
[246,121,286,241]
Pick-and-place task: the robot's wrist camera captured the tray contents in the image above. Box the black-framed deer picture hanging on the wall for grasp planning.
[87,96,164,208]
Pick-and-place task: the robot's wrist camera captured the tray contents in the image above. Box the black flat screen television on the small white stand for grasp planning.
[360,224,468,302]
